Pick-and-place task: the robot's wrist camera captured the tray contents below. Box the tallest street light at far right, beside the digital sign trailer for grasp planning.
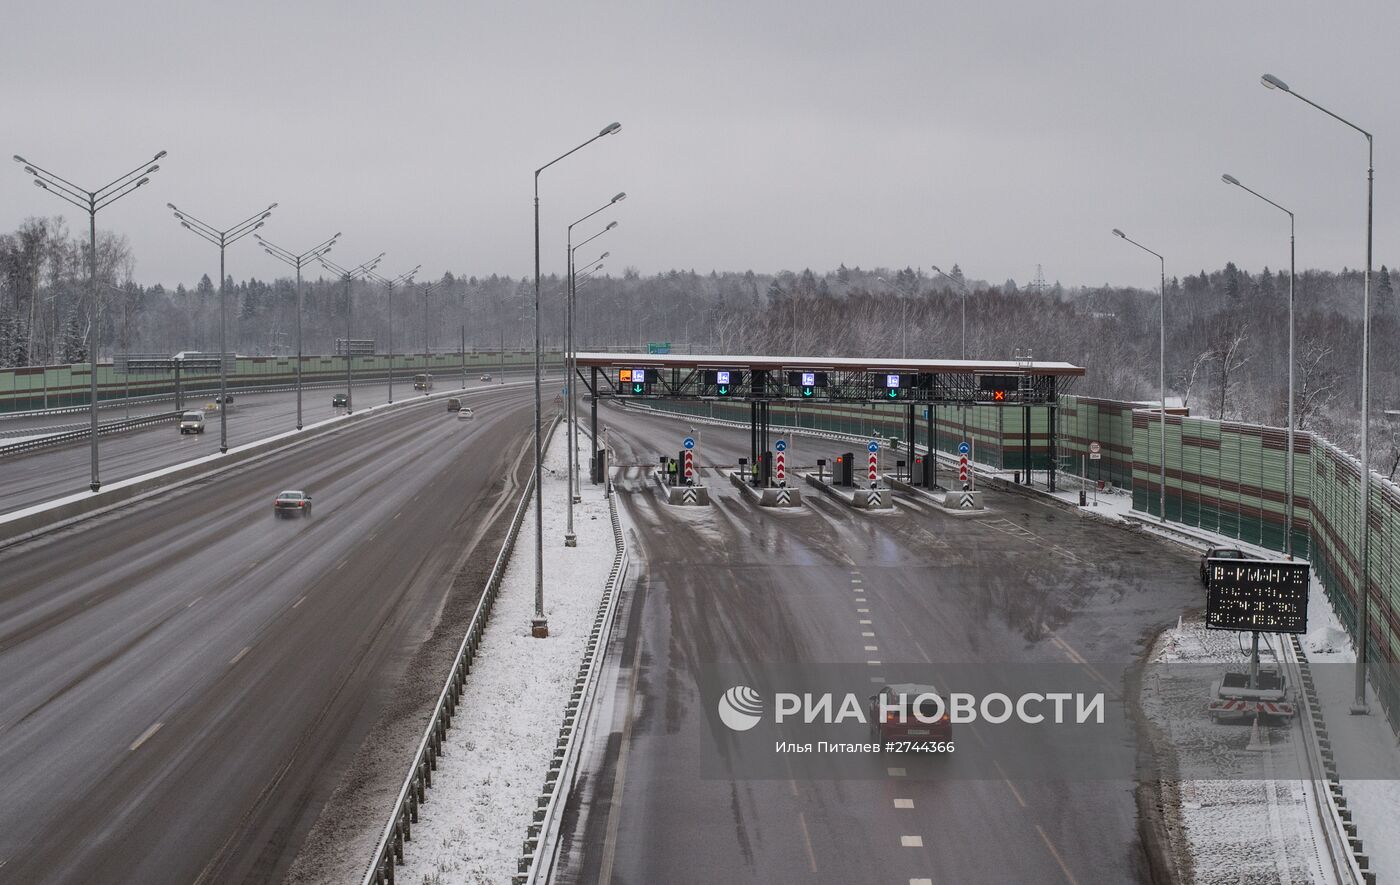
[1260,74,1376,716]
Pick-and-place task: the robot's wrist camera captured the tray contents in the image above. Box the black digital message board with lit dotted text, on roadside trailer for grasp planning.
[1205,557,1312,633]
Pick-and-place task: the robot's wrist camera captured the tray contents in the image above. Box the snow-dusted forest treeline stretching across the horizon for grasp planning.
[0,217,1400,468]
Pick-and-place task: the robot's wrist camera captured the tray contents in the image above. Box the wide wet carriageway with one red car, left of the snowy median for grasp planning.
[0,388,532,884]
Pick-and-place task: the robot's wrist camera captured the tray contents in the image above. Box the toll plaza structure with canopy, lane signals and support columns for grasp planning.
[575,353,1084,510]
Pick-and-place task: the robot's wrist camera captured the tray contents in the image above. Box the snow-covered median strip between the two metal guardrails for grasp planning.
[398,433,616,885]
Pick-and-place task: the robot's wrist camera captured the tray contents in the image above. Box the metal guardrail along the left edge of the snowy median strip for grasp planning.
[363,416,560,885]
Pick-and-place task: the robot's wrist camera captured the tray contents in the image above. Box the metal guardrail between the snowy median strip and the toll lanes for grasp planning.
[511,467,631,885]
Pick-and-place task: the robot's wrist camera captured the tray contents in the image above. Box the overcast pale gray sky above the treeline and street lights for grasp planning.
[0,0,1400,286]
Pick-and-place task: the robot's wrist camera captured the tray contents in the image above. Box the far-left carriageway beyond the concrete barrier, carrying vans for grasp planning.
[0,375,521,513]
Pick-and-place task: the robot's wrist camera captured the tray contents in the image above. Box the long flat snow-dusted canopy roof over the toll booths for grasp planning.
[578,351,1084,377]
